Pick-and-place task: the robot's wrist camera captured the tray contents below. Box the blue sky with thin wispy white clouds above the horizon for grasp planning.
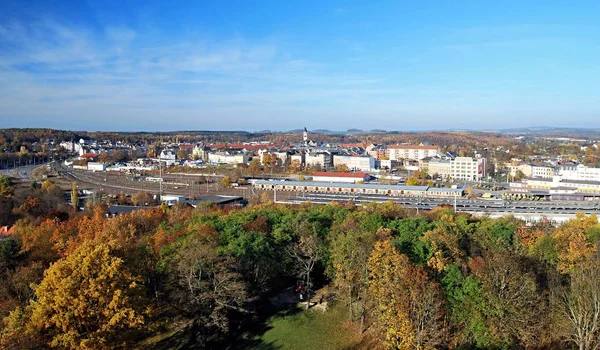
[0,0,600,131]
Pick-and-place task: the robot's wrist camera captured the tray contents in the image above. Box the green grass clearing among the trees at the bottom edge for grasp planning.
[255,305,359,349]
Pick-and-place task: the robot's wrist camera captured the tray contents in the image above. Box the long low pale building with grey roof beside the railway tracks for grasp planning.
[252,180,463,198]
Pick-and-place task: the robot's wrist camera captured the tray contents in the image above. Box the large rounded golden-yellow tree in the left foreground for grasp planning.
[27,241,144,349]
